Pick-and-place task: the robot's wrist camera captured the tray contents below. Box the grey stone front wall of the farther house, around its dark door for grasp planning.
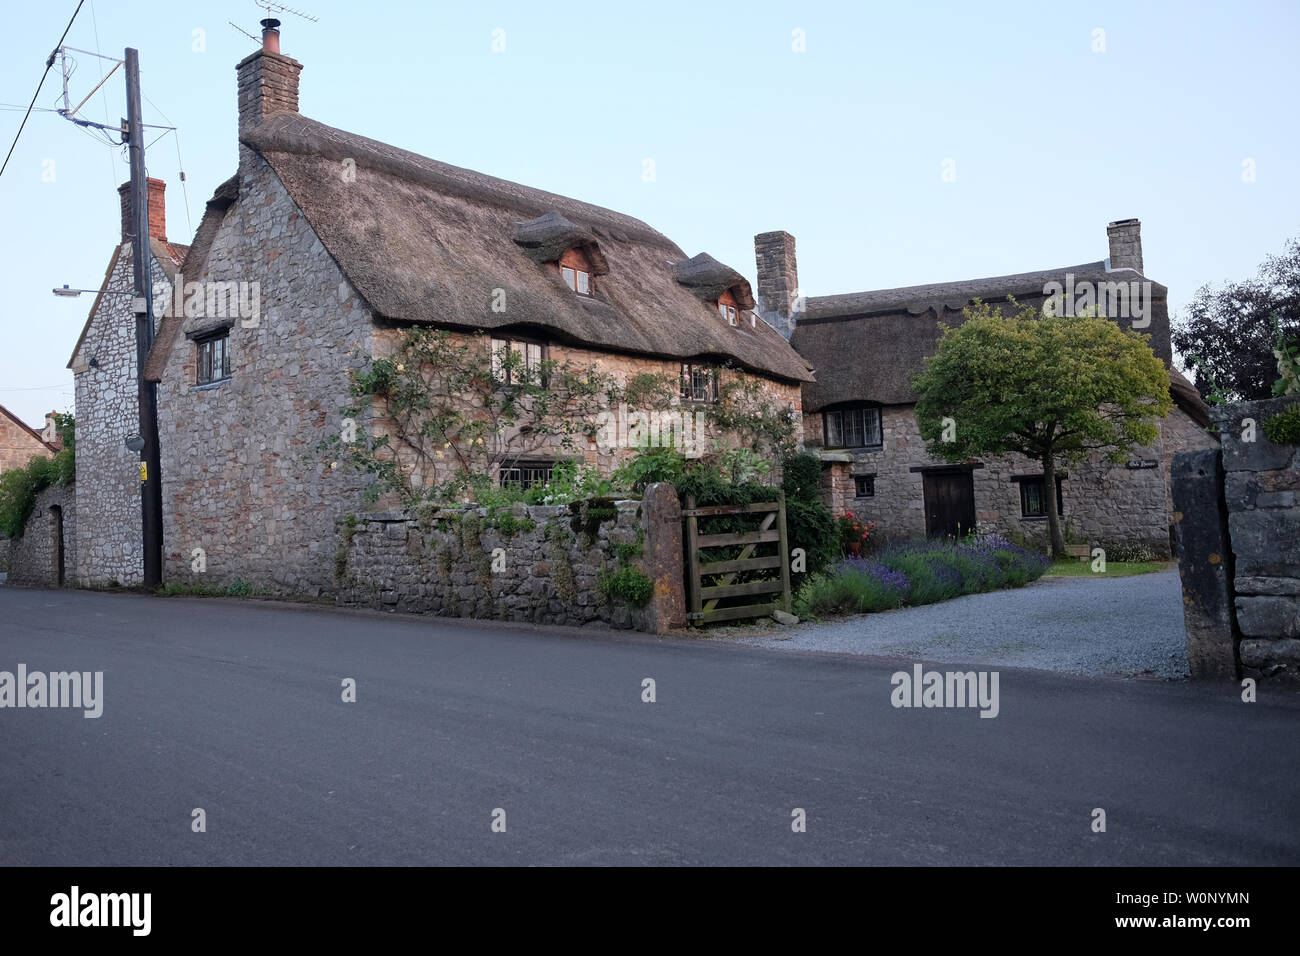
[803,406,1169,557]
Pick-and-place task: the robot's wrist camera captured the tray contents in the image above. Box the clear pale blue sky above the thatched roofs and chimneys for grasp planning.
[0,0,1300,424]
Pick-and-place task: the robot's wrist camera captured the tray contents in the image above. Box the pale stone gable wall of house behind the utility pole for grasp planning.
[69,242,172,588]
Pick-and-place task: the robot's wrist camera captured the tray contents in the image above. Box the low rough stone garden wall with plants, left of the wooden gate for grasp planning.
[334,485,685,632]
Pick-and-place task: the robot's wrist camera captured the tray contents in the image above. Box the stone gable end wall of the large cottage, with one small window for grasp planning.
[159,155,372,597]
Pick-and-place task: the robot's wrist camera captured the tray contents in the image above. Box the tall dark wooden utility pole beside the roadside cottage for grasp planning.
[126,47,163,591]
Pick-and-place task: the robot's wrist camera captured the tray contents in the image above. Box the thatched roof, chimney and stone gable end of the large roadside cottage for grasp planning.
[111,21,811,594]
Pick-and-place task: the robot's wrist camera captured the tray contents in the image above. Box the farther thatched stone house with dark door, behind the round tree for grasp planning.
[754,220,1218,555]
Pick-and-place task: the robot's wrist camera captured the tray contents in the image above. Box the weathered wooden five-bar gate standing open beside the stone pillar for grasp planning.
[681,494,790,626]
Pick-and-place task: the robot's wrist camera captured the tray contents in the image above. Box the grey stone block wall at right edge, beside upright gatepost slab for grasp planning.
[1212,397,1300,678]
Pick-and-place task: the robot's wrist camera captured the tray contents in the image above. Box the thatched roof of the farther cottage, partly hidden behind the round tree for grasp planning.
[790,261,1171,411]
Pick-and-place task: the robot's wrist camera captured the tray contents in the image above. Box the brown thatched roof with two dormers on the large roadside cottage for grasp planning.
[170,113,811,382]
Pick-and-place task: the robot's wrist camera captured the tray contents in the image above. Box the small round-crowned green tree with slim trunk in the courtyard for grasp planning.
[914,302,1173,557]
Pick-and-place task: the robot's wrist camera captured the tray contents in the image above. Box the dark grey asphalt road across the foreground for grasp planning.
[0,588,1300,865]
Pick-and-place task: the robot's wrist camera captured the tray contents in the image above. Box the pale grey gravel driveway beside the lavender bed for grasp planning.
[732,568,1187,678]
